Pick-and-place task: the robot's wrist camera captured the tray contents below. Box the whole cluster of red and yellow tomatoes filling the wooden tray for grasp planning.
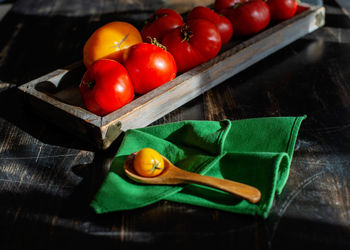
[80,0,298,116]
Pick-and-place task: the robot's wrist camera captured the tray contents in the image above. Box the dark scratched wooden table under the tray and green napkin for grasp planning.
[0,0,350,249]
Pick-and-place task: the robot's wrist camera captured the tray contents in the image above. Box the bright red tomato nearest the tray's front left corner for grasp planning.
[79,59,134,116]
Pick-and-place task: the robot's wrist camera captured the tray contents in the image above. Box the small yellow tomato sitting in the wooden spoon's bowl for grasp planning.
[133,148,164,177]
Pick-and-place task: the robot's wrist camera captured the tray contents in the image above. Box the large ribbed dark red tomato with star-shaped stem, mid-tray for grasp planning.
[162,19,221,72]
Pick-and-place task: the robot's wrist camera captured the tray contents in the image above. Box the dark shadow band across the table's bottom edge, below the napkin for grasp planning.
[0,203,350,250]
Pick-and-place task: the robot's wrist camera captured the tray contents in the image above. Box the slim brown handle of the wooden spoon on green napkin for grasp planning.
[175,170,261,203]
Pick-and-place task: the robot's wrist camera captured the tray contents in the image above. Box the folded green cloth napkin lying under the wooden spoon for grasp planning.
[90,117,305,217]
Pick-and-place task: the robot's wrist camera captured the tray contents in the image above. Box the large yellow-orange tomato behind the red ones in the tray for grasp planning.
[83,22,142,67]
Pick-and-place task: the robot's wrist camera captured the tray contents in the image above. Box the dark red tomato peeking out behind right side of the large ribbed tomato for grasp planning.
[187,6,233,45]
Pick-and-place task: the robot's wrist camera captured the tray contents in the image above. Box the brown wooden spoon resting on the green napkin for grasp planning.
[124,153,261,203]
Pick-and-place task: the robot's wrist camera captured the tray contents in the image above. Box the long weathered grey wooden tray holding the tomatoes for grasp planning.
[19,5,325,149]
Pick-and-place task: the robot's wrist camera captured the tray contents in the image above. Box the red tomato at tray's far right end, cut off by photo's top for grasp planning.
[267,0,298,20]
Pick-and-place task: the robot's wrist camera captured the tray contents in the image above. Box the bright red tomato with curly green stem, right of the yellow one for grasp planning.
[124,43,177,94]
